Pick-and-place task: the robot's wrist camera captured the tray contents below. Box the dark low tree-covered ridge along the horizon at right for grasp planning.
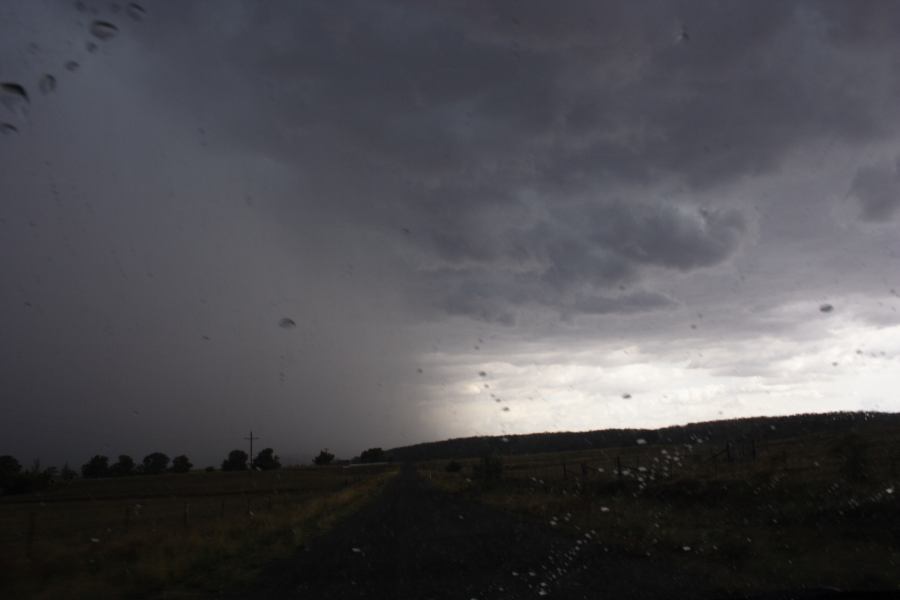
[389,412,900,461]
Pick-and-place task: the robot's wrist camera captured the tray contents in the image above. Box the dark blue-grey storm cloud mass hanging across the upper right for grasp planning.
[116,2,897,322]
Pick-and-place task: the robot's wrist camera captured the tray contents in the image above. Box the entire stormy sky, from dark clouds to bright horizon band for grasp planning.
[0,0,900,466]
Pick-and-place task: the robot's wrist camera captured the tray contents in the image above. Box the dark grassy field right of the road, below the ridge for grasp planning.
[421,425,900,593]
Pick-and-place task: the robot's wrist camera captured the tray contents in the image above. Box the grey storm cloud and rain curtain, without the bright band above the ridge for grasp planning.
[0,0,900,464]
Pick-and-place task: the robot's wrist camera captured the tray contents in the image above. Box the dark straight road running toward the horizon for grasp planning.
[231,467,887,600]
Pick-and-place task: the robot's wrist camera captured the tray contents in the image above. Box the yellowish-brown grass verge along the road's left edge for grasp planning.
[0,471,396,599]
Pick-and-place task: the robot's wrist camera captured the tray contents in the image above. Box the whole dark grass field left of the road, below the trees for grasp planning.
[0,467,396,598]
